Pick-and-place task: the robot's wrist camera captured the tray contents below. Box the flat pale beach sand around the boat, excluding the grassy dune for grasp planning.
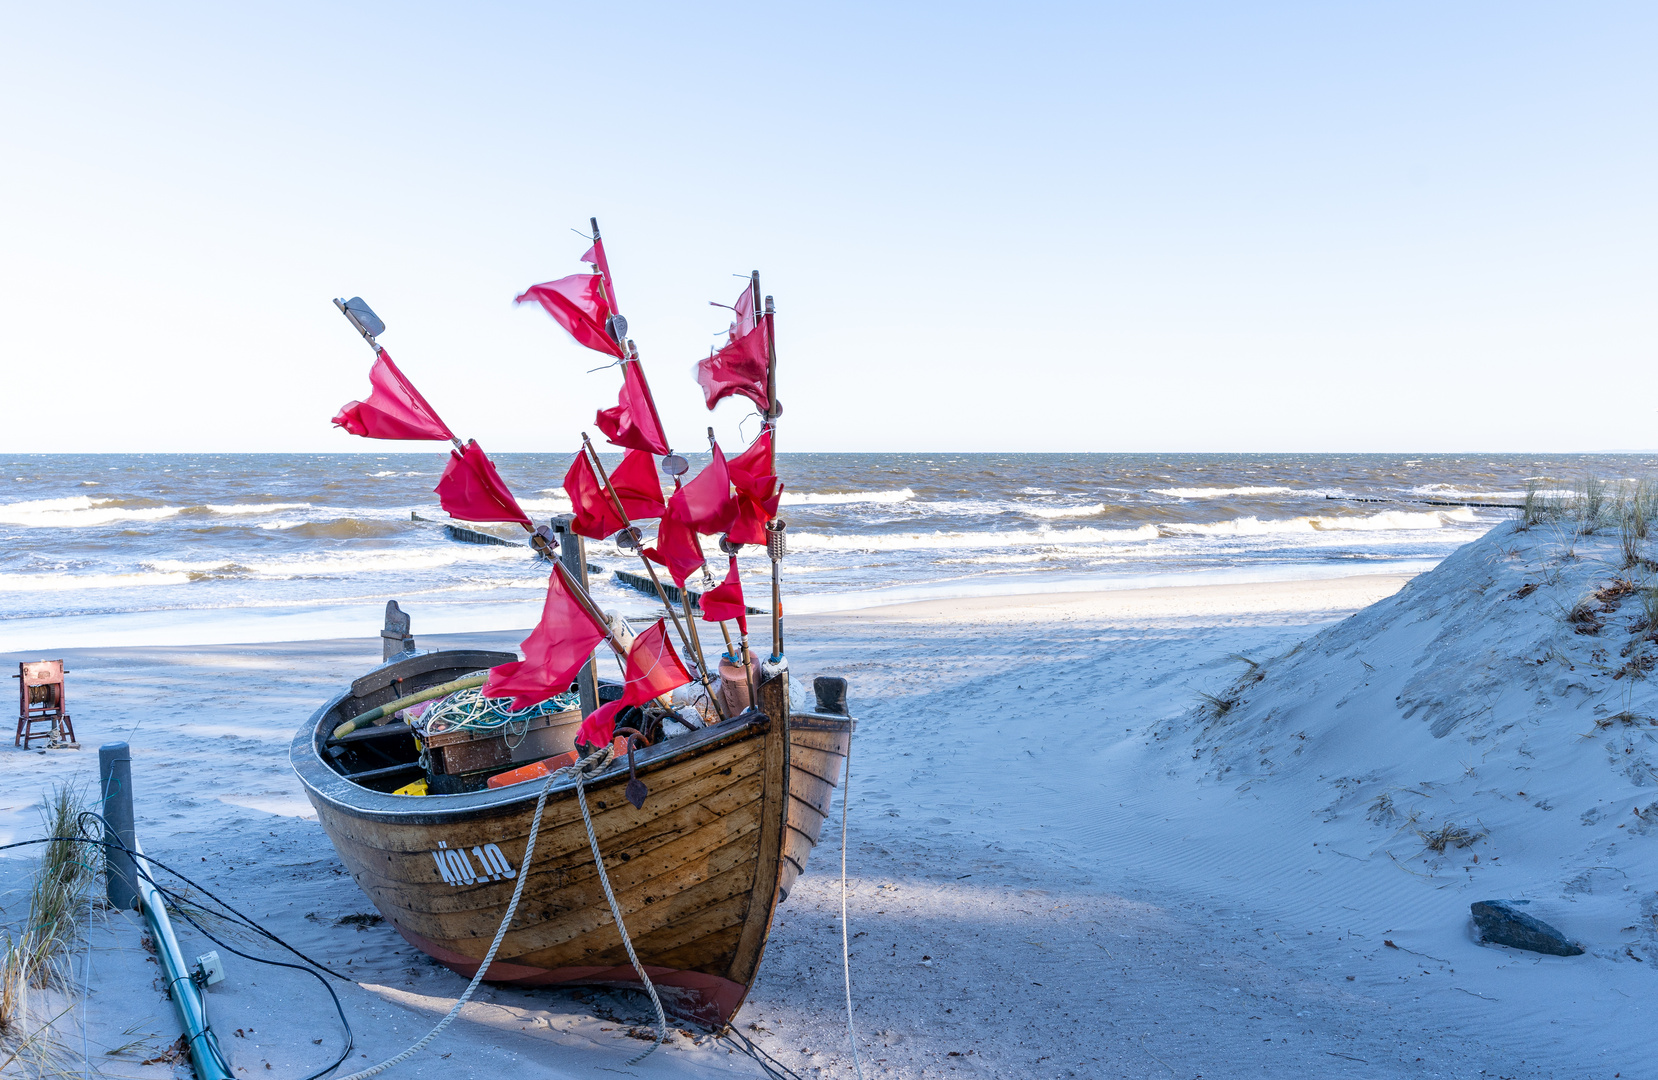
[0,576,1631,1078]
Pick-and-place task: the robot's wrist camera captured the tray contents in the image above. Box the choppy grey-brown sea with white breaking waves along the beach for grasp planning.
[0,451,1658,652]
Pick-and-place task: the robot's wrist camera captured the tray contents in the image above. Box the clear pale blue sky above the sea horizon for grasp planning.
[0,2,1658,451]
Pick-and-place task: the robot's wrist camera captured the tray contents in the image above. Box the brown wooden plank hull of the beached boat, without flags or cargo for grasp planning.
[290,650,854,1025]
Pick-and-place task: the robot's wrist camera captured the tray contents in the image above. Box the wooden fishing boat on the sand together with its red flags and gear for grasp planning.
[303,221,852,1024]
